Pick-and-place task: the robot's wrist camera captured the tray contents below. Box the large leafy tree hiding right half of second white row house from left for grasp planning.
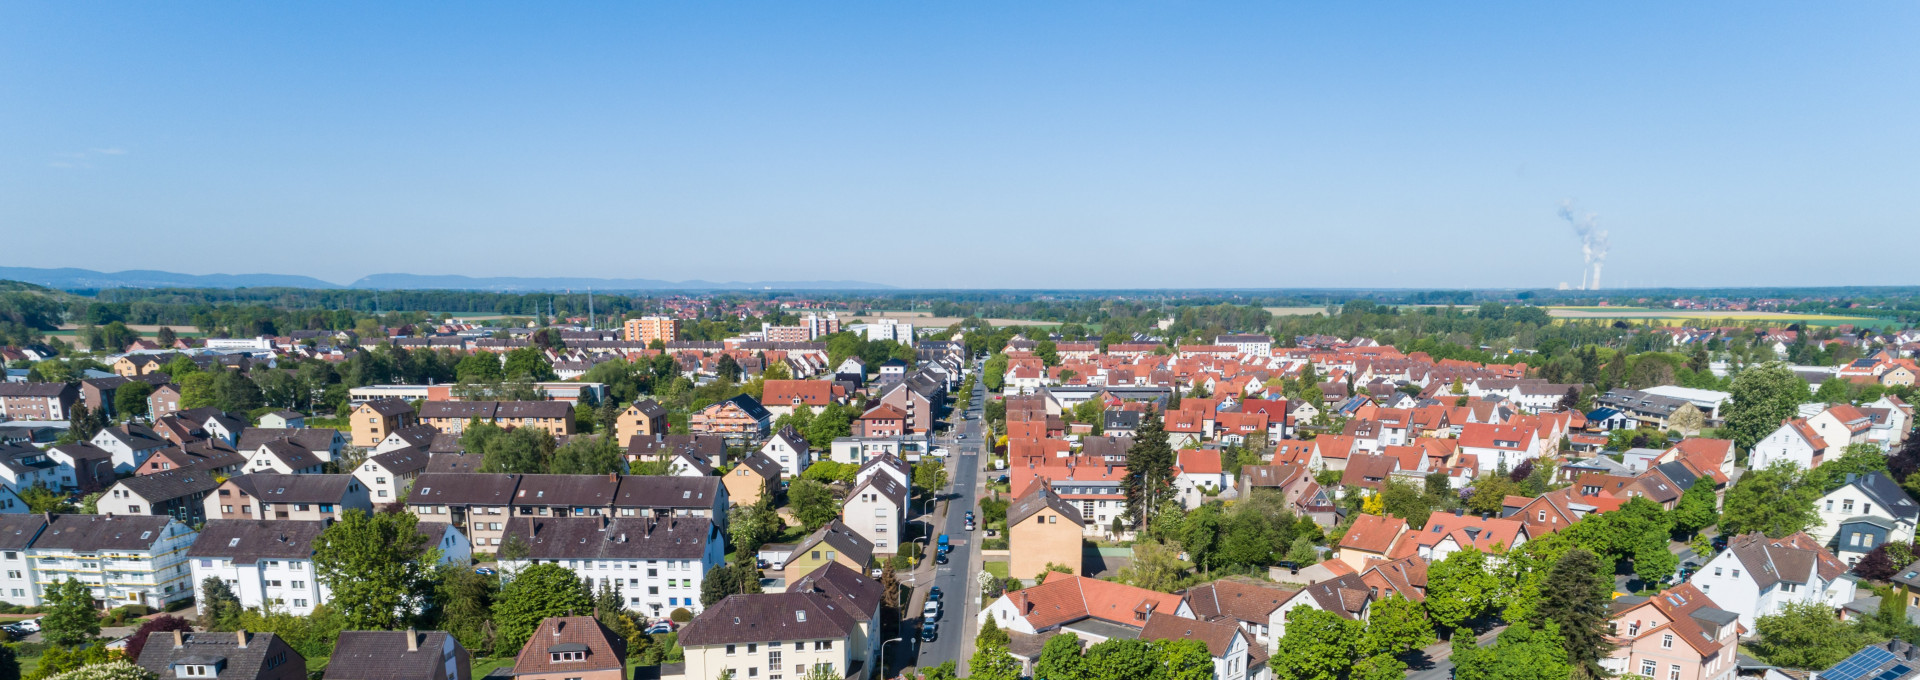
[313,509,436,630]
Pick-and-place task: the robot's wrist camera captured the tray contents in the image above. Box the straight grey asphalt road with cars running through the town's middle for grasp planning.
[914,363,987,678]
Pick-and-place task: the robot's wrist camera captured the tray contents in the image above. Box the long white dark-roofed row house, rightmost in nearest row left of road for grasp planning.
[501,515,726,619]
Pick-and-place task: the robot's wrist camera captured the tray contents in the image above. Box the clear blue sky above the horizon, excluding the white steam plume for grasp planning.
[0,0,1920,288]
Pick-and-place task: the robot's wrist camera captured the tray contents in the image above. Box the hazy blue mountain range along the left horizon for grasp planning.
[0,267,893,292]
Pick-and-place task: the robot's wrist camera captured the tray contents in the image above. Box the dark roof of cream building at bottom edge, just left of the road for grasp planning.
[680,592,858,647]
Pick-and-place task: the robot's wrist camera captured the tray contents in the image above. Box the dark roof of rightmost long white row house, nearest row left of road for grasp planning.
[507,517,720,559]
